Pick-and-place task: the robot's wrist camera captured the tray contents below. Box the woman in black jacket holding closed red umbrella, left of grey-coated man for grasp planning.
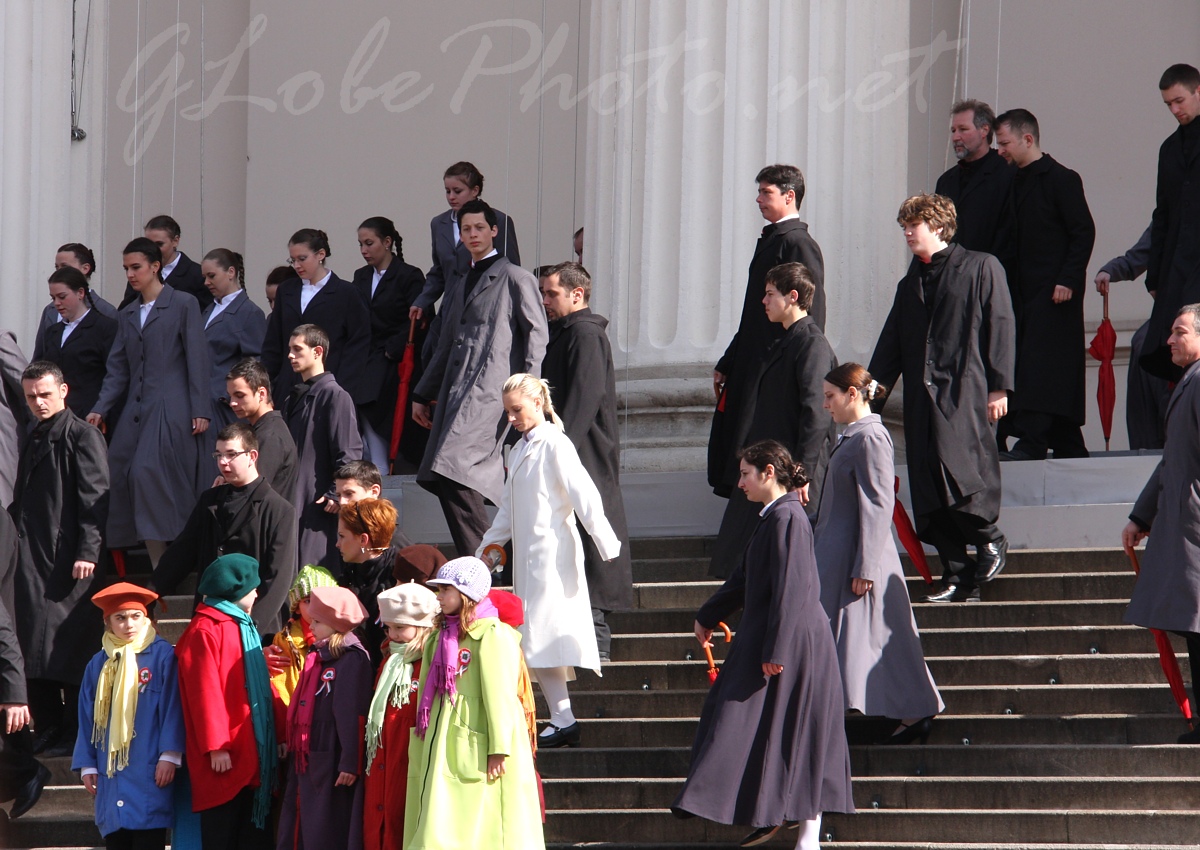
[354,216,430,472]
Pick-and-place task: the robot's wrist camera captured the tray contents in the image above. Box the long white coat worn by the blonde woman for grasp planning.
[476,423,620,674]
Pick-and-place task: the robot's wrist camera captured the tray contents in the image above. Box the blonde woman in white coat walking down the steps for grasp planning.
[476,373,620,748]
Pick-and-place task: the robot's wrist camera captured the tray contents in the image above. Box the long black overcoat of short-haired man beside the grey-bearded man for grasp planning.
[1002,154,1096,425]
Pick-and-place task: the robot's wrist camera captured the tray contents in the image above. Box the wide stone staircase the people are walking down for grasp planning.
[7,538,1200,850]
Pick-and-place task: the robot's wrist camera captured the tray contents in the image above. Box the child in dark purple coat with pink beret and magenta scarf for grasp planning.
[276,587,371,850]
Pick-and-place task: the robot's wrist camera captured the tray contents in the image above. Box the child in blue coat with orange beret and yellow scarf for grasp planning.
[72,581,184,850]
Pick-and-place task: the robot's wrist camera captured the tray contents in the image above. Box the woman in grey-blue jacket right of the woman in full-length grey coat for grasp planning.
[200,249,266,453]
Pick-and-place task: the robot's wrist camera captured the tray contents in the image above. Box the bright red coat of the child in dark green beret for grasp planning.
[175,604,258,812]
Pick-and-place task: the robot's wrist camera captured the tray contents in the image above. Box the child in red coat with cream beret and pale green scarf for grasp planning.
[362,582,439,850]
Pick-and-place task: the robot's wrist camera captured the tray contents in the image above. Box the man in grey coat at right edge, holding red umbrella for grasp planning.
[1121,304,1200,743]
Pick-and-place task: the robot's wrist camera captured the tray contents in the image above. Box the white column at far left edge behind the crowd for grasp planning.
[0,0,108,357]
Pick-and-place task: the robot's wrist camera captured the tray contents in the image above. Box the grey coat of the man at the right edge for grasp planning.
[1126,363,1200,631]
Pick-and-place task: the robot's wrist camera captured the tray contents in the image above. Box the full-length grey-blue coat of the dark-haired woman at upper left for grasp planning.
[94,286,215,549]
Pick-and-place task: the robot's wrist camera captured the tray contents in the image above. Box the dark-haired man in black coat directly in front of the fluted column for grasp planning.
[708,164,826,498]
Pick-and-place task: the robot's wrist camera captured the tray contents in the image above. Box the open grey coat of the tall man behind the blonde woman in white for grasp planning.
[415,257,548,504]
